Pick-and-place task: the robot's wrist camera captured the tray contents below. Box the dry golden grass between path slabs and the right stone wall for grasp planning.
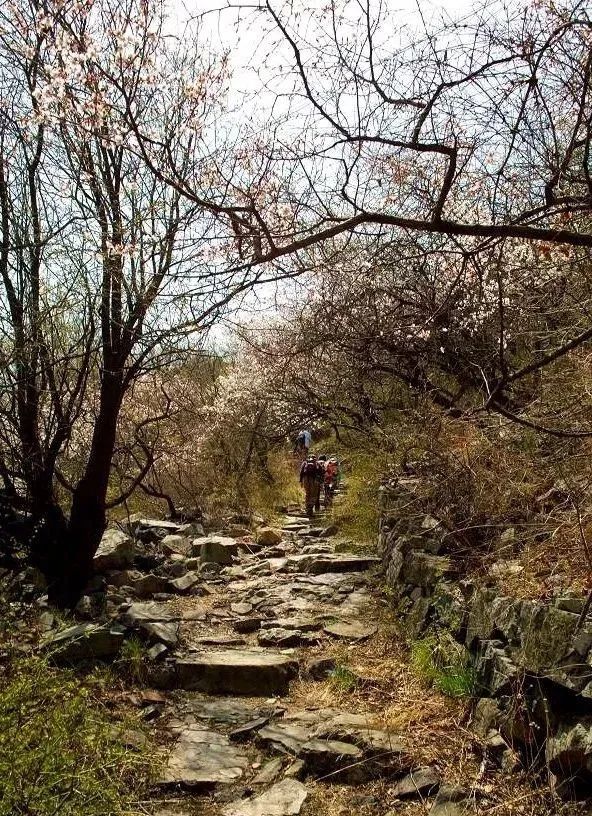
[286,602,589,816]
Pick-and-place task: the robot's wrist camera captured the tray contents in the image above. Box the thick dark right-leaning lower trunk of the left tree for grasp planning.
[50,373,123,608]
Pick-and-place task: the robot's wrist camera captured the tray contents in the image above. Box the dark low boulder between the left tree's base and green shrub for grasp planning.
[41,623,125,665]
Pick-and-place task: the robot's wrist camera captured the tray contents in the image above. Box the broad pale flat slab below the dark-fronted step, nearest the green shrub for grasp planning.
[158,727,249,788]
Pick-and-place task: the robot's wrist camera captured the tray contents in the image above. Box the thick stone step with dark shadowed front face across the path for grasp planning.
[176,649,298,697]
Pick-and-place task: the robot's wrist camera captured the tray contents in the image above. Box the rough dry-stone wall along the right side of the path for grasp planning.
[379,479,592,795]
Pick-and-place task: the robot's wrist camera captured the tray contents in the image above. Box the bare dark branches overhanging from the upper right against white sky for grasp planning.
[125,0,592,433]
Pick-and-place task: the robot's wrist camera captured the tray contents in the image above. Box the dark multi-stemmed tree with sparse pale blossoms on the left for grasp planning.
[0,0,282,604]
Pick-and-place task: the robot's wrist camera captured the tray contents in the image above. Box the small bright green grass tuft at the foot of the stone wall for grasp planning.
[410,632,477,697]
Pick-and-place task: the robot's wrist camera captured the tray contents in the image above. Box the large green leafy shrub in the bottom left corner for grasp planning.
[0,659,148,816]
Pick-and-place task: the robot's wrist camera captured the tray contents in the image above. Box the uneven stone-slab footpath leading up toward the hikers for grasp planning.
[112,515,465,816]
